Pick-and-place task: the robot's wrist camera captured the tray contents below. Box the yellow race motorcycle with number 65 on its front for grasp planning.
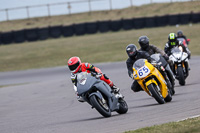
[133,59,172,104]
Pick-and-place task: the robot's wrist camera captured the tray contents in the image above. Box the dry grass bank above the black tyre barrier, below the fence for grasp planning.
[0,1,200,32]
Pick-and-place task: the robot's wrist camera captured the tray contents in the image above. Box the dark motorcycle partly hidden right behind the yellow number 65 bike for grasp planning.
[151,54,175,95]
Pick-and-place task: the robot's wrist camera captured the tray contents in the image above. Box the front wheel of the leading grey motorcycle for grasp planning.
[90,95,111,117]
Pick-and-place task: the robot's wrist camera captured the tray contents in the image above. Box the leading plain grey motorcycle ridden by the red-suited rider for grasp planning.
[77,72,128,117]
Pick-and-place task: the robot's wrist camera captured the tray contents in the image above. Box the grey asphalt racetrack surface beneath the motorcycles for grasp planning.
[0,56,200,133]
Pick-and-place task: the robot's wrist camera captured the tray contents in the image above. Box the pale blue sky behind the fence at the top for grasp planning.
[0,0,191,21]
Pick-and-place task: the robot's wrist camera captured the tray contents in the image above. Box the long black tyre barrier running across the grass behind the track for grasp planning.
[0,12,200,44]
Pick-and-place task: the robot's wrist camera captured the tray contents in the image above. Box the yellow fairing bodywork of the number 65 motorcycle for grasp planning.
[133,60,168,98]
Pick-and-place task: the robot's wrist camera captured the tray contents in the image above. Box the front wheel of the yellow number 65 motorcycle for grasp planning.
[147,84,165,104]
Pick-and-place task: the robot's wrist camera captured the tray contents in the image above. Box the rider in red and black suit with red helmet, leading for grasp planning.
[68,56,120,102]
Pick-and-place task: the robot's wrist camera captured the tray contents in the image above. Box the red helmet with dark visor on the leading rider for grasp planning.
[68,56,81,73]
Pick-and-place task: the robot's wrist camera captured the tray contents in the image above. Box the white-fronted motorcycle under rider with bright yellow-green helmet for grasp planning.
[169,45,189,85]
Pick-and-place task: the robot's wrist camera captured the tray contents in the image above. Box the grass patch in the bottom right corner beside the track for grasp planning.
[125,117,200,133]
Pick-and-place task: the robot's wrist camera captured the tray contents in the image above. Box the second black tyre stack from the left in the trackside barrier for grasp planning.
[13,30,26,43]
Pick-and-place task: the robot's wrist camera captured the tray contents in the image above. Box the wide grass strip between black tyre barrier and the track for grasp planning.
[0,24,200,71]
